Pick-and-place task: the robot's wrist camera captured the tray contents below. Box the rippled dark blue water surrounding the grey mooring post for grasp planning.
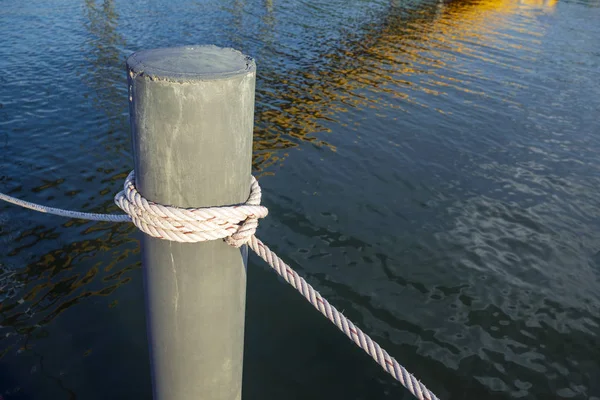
[0,0,600,400]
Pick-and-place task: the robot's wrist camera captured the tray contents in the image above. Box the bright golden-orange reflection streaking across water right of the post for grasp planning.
[254,0,556,171]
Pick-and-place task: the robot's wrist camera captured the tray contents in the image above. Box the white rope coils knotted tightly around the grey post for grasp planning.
[115,171,268,247]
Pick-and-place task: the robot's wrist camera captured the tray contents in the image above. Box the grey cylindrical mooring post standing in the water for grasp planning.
[127,46,256,400]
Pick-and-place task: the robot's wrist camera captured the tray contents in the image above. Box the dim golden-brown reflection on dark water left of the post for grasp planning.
[0,174,141,357]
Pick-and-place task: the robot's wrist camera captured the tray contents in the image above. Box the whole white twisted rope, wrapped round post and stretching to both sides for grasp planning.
[0,171,438,400]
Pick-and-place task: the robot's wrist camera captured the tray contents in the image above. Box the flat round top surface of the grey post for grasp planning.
[127,45,256,82]
